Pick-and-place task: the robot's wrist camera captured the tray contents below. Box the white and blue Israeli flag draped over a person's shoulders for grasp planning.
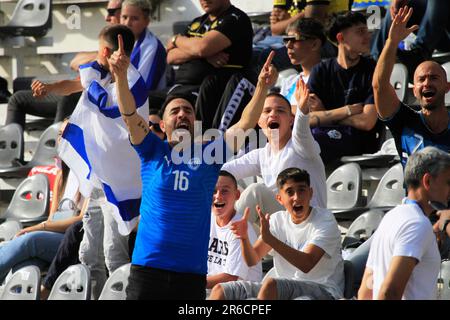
[59,62,148,235]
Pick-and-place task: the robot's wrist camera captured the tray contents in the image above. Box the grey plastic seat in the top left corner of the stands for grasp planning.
[0,0,52,37]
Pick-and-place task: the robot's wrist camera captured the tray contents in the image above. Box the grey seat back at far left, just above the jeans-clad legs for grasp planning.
[0,174,50,223]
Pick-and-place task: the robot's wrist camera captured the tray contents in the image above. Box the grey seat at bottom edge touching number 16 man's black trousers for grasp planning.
[98,263,131,300]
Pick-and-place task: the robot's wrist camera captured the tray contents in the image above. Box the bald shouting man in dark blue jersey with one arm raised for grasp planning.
[372,6,450,166]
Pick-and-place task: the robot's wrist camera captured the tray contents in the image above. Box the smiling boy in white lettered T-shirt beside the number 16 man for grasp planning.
[206,171,262,289]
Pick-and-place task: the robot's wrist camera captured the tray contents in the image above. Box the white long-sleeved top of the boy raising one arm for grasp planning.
[222,110,327,208]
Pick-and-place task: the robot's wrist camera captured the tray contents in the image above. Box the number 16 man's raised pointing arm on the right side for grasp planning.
[225,51,278,151]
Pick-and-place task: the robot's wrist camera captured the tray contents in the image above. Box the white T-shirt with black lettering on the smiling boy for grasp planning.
[208,214,262,282]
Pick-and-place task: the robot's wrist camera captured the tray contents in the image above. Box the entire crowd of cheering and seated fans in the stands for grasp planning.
[0,0,450,299]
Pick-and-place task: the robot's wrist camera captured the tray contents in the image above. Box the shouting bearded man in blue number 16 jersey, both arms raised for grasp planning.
[110,40,277,300]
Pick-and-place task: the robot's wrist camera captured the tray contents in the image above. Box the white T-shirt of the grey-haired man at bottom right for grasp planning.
[367,203,441,300]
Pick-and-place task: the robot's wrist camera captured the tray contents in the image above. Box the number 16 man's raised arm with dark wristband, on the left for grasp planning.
[108,35,150,145]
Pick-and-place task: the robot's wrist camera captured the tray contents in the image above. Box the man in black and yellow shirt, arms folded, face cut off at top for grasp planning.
[166,0,254,130]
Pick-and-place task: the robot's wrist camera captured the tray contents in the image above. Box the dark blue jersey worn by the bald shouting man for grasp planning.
[383,103,450,167]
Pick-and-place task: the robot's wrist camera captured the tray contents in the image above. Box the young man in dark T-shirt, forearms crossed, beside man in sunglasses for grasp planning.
[308,11,381,165]
